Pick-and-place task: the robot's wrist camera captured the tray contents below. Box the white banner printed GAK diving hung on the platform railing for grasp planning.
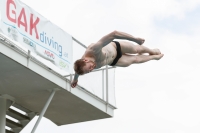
[0,0,73,73]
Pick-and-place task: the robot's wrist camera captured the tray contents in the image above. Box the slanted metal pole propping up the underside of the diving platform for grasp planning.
[31,89,58,133]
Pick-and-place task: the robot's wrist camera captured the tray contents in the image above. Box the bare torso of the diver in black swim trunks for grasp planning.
[82,42,117,69]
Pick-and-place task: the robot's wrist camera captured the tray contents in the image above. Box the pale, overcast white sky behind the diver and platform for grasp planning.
[18,0,200,133]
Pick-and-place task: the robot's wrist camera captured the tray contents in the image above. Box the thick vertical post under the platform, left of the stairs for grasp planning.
[0,98,6,133]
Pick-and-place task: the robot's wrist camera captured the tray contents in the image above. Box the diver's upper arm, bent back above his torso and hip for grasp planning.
[91,31,144,50]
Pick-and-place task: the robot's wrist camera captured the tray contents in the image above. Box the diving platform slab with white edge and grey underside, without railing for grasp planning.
[0,34,116,132]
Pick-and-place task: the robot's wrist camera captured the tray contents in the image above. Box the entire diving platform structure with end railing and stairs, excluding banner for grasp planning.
[0,33,116,133]
